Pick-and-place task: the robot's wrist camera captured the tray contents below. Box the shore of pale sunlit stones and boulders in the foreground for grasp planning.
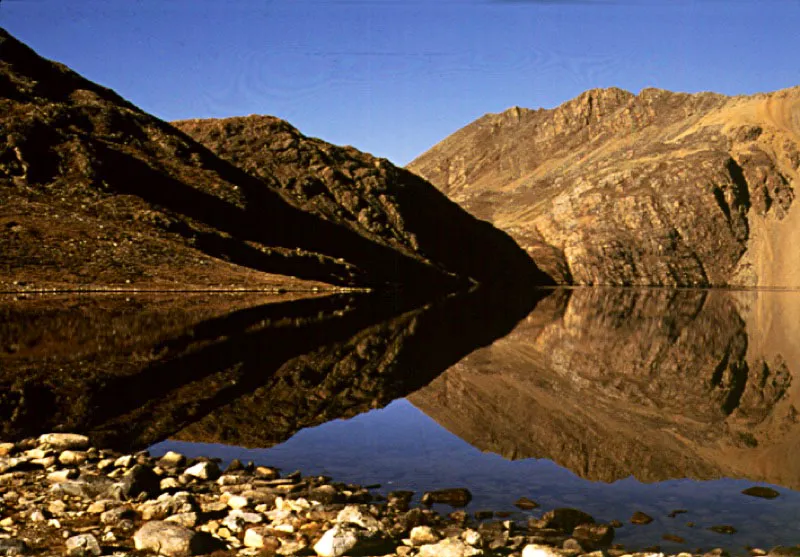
[0,433,800,557]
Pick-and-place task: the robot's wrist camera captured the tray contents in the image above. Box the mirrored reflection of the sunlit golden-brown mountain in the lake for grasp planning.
[408,289,800,487]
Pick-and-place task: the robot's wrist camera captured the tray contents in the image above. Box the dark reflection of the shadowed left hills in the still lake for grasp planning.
[0,289,552,448]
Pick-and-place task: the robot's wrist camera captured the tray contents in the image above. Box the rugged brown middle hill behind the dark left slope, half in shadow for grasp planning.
[173,116,551,284]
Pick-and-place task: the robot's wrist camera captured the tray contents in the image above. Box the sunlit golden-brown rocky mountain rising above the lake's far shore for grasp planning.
[408,87,800,286]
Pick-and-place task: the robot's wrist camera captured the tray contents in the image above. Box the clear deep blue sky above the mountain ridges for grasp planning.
[0,0,800,164]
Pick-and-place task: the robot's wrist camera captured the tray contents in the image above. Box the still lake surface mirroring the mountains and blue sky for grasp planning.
[0,289,800,553]
